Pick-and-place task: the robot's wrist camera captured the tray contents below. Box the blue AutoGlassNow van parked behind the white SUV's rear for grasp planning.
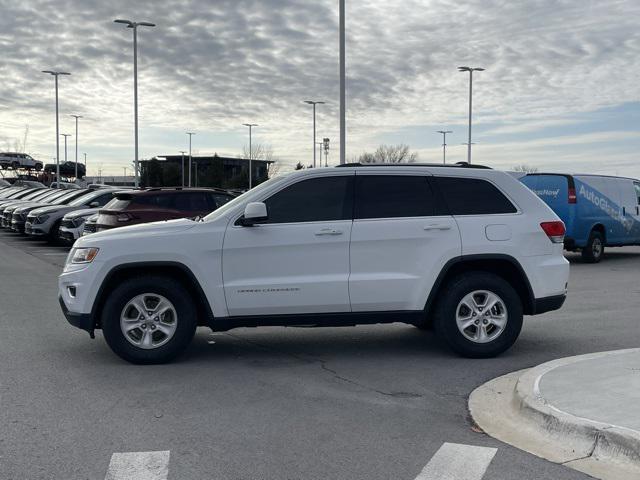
[520,173,640,263]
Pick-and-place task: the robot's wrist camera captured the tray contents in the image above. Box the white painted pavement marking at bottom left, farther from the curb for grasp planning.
[104,451,170,480]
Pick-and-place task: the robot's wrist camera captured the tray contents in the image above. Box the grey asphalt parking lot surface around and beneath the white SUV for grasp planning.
[0,232,640,480]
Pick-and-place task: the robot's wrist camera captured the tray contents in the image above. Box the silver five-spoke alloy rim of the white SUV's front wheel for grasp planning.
[120,293,178,350]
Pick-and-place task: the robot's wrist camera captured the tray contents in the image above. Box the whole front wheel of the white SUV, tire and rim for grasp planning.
[102,276,197,364]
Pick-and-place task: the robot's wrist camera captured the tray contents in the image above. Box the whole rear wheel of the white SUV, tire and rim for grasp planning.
[434,272,523,358]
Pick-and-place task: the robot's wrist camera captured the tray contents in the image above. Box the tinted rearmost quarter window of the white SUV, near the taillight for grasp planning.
[435,177,517,215]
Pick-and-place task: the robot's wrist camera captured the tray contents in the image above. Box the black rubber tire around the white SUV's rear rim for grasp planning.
[434,272,523,358]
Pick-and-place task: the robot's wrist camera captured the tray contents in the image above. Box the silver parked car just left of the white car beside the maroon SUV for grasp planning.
[24,189,120,242]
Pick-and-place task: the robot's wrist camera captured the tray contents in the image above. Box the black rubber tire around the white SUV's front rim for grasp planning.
[101,276,197,365]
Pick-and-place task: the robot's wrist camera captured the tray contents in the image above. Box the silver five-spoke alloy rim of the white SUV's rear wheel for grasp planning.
[456,290,509,343]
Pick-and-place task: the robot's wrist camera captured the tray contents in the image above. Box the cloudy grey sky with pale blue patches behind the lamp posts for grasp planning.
[0,0,640,177]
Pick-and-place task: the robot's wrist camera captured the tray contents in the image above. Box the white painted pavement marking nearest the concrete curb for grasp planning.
[415,443,498,480]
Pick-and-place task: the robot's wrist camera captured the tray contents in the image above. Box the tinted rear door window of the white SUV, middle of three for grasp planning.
[354,175,433,218]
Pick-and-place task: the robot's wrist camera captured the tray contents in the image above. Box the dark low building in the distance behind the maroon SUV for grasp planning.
[140,154,274,189]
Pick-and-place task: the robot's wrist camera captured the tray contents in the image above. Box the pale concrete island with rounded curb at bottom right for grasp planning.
[469,349,640,480]
